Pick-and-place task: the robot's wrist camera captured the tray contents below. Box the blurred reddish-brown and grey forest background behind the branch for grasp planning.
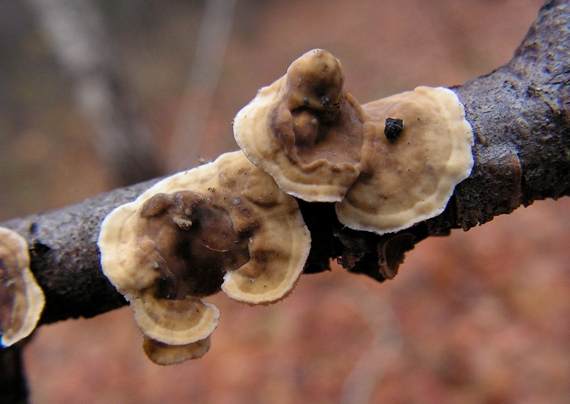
[0,0,570,404]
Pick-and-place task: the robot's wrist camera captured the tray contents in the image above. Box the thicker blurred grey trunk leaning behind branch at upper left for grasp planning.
[28,0,162,186]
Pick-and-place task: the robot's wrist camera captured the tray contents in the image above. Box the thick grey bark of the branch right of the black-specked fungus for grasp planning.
[454,1,570,229]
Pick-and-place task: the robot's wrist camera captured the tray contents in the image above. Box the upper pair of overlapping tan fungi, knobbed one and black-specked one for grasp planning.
[234,49,473,234]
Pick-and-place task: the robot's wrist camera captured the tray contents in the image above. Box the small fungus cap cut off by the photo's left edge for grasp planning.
[0,227,45,347]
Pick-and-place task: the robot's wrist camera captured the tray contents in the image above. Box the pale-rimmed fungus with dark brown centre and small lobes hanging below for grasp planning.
[98,151,311,364]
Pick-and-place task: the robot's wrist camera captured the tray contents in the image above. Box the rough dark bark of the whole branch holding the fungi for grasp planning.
[0,0,570,323]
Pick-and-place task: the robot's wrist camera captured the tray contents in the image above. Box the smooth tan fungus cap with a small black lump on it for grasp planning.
[336,87,473,234]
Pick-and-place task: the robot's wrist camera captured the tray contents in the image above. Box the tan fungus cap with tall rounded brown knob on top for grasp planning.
[233,49,362,202]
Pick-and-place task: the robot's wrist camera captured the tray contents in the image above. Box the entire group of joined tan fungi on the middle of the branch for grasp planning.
[98,49,473,365]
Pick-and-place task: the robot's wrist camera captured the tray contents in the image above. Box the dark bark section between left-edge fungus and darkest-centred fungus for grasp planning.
[2,180,158,323]
